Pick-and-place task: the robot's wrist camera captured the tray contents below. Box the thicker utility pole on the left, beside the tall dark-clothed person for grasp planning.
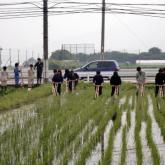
[43,0,48,82]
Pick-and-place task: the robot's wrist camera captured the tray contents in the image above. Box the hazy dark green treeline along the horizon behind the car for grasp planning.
[49,47,165,69]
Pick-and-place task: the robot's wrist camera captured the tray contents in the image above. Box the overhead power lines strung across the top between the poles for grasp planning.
[0,1,165,19]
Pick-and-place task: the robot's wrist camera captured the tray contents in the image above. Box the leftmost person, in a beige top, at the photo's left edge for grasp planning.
[0,66,8,94]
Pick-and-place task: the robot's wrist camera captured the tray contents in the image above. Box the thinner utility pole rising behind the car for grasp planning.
[101,0,105,60]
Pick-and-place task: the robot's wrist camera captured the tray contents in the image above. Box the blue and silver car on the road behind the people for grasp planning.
[74,60,120,79]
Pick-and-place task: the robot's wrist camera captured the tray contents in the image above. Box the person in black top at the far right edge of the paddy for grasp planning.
[155,68,165,97]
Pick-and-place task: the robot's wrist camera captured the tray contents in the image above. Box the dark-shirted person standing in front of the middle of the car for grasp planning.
[93,71,104,96]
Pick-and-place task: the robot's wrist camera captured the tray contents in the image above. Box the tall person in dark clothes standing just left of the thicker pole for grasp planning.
[34,58,44,85]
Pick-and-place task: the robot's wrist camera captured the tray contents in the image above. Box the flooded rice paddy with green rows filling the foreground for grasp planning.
[0,83,165,165]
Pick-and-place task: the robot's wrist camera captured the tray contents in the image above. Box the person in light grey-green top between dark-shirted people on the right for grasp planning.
[136,67,146,96]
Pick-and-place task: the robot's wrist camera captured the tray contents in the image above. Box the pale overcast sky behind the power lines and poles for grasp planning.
[0,0,165,65]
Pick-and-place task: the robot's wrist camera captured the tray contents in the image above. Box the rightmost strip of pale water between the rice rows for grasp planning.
[148,97,165,165]
